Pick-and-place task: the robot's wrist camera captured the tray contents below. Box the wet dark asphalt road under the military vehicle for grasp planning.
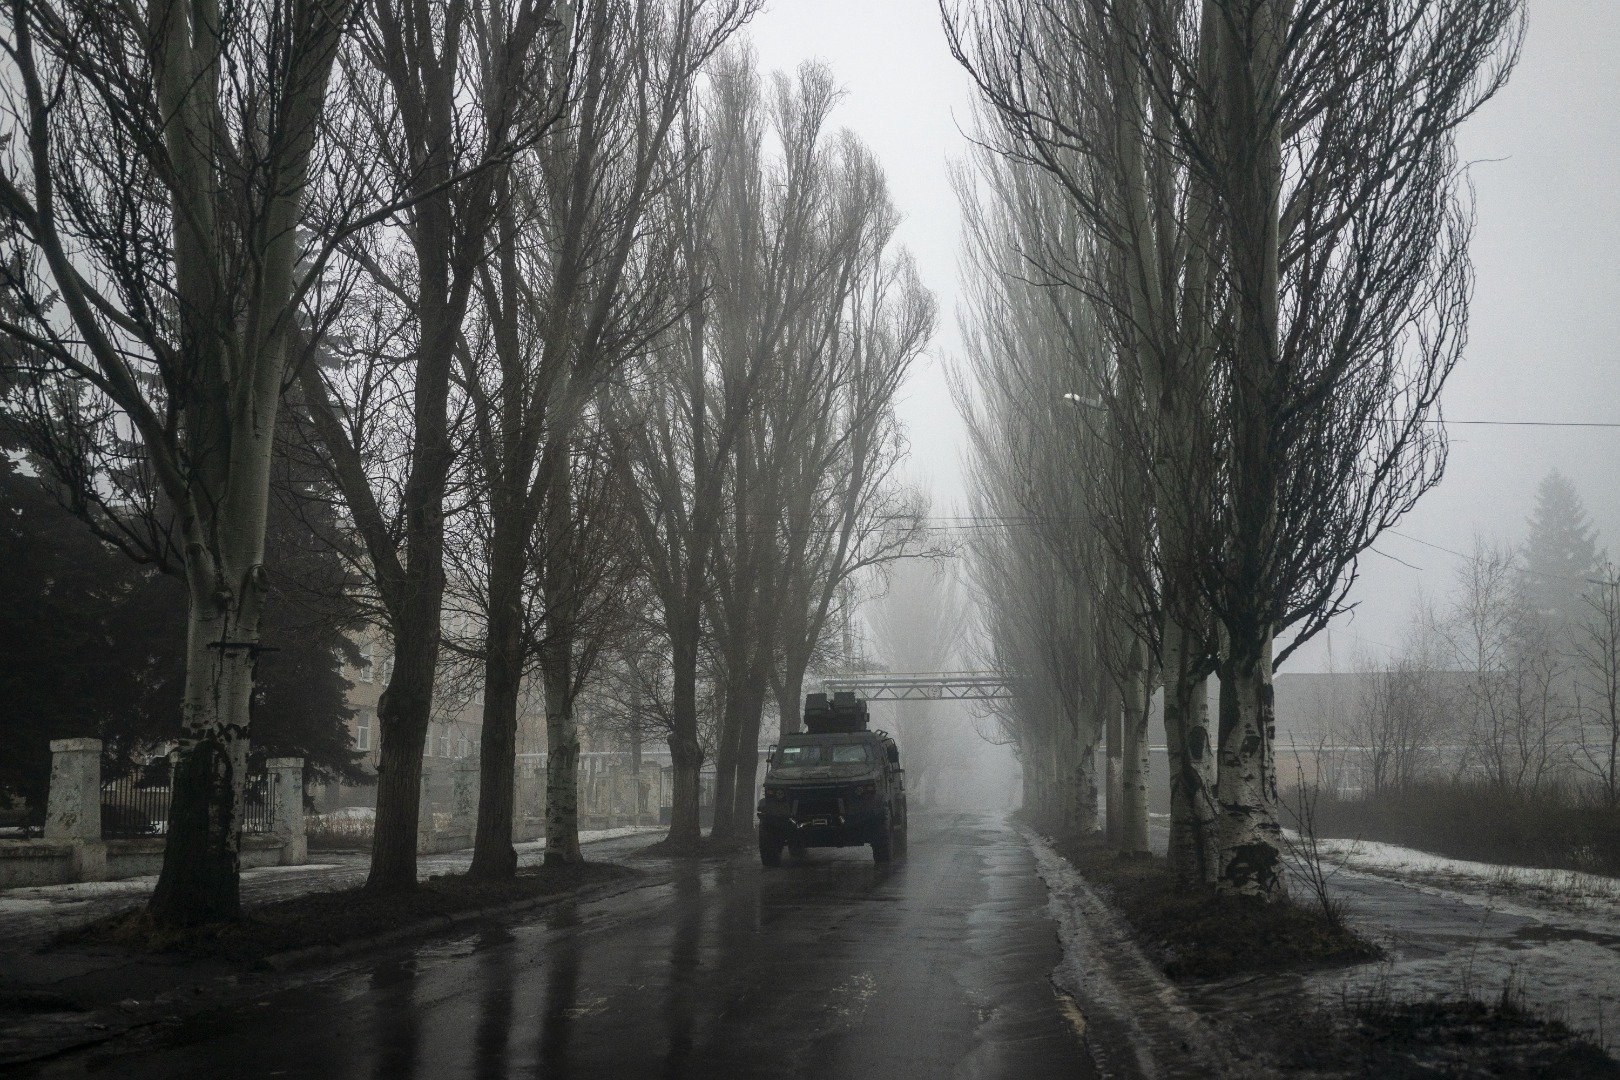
[25,814,1094,1080]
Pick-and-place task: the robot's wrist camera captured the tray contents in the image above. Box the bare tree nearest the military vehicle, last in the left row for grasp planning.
[711,63,933,836]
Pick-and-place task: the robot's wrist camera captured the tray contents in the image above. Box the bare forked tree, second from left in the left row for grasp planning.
[300,0,563,889]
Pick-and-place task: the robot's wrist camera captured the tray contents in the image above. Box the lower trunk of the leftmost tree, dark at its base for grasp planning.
[147,586,259,926]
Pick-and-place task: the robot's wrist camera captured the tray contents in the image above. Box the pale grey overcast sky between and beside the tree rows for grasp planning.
[750,0,1620,670]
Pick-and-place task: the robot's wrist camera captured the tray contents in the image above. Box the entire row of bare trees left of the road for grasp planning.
[0,0,933,923]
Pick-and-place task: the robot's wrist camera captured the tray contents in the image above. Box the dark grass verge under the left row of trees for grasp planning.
[52,863,640,963]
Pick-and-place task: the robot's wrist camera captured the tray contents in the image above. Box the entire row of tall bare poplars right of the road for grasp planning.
[943,0,1521,899]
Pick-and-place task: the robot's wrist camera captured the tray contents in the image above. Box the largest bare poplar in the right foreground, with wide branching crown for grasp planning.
[946,0,1520,897]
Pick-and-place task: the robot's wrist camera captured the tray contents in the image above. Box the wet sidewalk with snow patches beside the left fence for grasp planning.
[0,827,663,1067]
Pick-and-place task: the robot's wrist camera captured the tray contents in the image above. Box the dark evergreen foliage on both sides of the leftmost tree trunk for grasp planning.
[0,427,368,813]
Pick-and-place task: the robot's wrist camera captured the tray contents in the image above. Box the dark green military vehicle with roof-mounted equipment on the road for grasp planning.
[760,693,906,866]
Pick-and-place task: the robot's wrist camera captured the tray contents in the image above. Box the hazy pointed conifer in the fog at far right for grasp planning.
[1520,470,1604,635]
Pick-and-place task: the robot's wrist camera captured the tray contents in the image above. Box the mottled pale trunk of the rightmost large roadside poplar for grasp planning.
[1217,635,1283,900]
